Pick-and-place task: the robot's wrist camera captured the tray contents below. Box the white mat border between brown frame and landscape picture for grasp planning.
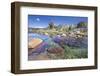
[20,6,94,70]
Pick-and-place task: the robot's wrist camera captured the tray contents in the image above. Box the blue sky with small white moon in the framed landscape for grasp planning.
[28,15,88,28]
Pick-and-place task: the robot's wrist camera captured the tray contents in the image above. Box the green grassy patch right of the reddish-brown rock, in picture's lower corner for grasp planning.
[64,45,88,59]
